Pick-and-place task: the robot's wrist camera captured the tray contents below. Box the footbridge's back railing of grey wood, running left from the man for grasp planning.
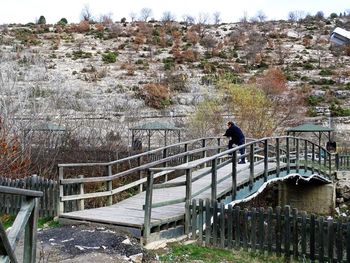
[58,137,227,214]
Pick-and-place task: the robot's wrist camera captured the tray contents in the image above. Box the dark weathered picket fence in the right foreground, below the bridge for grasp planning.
[186,199,350,262]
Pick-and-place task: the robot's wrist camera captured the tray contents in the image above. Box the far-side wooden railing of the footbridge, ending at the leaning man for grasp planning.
[58,137,226,214]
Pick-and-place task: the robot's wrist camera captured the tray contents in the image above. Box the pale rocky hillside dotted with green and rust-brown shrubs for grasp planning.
[0,16,350,150]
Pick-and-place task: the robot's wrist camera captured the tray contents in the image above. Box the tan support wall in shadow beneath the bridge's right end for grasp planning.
[278,182,335,215]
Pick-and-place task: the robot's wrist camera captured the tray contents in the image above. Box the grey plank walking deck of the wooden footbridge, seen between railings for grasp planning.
[60,163,275,233]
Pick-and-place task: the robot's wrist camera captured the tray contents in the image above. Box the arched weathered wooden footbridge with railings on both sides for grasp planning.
[59,136,337,242]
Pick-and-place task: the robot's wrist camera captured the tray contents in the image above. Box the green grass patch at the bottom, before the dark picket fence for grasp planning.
[159,243,300,263]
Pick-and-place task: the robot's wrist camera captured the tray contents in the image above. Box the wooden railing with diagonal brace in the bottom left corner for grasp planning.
[0,186,43,263]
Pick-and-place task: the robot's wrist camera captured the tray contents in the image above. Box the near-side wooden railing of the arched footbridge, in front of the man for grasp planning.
[144,136,335,240]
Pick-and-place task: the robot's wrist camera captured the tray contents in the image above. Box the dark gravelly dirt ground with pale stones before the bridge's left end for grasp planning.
[16,225,158,263]
